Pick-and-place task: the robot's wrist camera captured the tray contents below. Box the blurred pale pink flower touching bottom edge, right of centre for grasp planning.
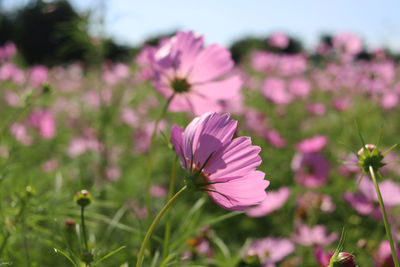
[245,237,296,267]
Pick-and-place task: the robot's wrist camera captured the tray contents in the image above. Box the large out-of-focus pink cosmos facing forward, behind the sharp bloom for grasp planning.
[152,32,242,115]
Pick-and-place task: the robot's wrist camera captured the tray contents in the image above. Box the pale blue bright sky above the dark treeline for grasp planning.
[3,0,400,51]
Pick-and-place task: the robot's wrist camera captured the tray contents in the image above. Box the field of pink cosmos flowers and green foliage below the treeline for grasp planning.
[0,31,400,267]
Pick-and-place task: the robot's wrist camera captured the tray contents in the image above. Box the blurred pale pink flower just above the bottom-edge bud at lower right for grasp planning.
[292,225,339,246]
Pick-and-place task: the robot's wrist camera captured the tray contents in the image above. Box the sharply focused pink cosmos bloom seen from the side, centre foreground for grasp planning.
[171,113,269,210]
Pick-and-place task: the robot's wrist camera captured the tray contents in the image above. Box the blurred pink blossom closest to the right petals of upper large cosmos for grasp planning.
[261,77,292,105]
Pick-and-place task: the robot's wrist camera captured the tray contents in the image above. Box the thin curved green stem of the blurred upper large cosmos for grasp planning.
[146,94,175,222]
